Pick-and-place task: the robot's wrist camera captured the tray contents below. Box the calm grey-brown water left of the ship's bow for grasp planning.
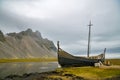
[0,62,58,78]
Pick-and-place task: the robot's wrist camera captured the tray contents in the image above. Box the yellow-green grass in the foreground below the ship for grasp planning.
[51,67,120,80]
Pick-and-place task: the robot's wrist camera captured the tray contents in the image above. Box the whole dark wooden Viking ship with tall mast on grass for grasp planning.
[57,22,106,67]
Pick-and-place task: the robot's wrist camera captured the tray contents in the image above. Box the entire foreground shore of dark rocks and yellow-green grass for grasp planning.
[0,66,120,80]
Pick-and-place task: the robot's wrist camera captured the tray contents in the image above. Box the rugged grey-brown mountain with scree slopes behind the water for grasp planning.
[0,29,57,59]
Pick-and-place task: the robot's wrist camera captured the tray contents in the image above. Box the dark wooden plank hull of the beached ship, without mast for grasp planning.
[58,50,104,67]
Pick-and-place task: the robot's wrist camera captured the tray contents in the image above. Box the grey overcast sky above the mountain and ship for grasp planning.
[0,0,120,57]
